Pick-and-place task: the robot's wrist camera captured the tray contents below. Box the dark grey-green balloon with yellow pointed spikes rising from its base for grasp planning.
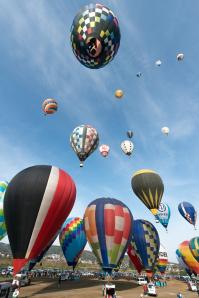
[131,169,164,215]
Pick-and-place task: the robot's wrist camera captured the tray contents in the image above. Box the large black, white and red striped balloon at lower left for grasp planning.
[4,165,76,274]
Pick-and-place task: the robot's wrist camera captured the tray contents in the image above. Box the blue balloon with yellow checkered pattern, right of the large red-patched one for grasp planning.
[132,219,160,276]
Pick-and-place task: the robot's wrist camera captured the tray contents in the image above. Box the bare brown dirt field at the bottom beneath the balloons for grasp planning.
[20,279,198,298]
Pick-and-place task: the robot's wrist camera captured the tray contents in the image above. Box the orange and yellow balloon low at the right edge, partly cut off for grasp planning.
[178,241,199,274]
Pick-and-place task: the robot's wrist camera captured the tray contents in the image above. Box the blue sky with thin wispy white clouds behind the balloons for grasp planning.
[0,0,199,261]
